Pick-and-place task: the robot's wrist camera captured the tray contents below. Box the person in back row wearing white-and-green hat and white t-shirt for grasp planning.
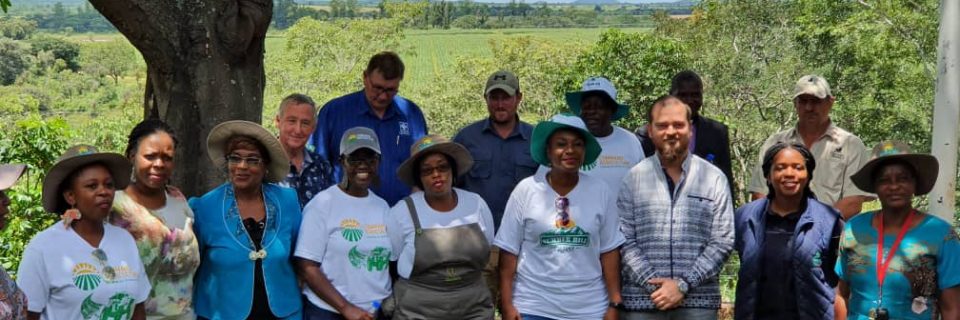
[564,77,643,196]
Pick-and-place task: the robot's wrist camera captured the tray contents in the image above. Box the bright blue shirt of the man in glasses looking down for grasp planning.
[310,90,427,206]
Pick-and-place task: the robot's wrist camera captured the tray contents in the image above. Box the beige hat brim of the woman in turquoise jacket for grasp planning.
[207,120,290,182]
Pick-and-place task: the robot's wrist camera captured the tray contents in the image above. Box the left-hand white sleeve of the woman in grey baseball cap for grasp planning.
[293,196,330,263]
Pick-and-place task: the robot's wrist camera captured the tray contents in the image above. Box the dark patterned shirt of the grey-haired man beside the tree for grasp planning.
[280,149,333,209]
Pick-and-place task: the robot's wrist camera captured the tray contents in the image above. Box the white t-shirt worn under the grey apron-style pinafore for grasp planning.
[387,188,493,279]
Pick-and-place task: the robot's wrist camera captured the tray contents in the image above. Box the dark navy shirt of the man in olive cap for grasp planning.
[453,118,537,230]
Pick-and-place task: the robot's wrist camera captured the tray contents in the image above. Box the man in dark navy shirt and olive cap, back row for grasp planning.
[453,70,537,305]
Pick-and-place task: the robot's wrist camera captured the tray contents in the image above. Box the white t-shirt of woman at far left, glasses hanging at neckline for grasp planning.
[17,223,150,320]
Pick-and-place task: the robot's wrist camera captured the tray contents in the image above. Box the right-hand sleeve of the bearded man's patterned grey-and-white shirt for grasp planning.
[682,176,734,288]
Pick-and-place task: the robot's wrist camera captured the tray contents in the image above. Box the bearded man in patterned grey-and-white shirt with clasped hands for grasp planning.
[616,96,734,320]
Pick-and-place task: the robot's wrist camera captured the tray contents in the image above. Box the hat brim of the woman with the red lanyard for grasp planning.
[850,153,940,195]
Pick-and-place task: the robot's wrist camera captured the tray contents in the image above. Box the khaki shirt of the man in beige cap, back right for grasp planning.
[748,123,871,205]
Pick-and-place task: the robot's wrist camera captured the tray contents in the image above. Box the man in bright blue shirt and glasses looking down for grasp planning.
[310,51,427,206]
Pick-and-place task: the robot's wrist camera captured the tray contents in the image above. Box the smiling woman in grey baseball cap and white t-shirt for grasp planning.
[294,127,390,320]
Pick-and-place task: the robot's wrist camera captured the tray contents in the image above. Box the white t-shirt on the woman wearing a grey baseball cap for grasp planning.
[294,186,390,312]
